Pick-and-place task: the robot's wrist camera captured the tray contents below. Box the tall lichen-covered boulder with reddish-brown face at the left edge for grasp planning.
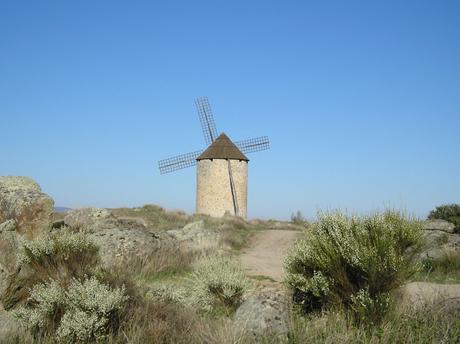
[0,176,54,237]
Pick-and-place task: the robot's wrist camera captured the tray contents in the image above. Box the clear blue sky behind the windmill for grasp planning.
[0,0,460,218]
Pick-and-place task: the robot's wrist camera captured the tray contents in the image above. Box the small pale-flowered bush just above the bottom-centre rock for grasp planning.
[190,256,249,310]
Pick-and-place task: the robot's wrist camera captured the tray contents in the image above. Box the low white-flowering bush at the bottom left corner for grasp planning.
[12,277,127,343]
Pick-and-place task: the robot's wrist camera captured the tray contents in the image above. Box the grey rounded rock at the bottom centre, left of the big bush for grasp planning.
[234,291,288,342]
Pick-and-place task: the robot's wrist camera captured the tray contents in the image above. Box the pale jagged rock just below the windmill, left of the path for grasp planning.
[166,220,221,250]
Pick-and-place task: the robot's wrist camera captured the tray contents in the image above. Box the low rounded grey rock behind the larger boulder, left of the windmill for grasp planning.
[64,208,118,231]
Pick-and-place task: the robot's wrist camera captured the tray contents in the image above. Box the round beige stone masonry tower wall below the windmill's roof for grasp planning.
[196,159,248,218]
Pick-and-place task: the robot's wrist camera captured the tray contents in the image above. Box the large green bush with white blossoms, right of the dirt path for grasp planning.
[285,211,421,322]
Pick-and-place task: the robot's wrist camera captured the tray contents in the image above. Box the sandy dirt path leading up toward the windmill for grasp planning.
[241,229,301,282]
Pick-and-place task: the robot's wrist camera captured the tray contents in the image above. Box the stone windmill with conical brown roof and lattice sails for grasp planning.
[158,97,270,217]
